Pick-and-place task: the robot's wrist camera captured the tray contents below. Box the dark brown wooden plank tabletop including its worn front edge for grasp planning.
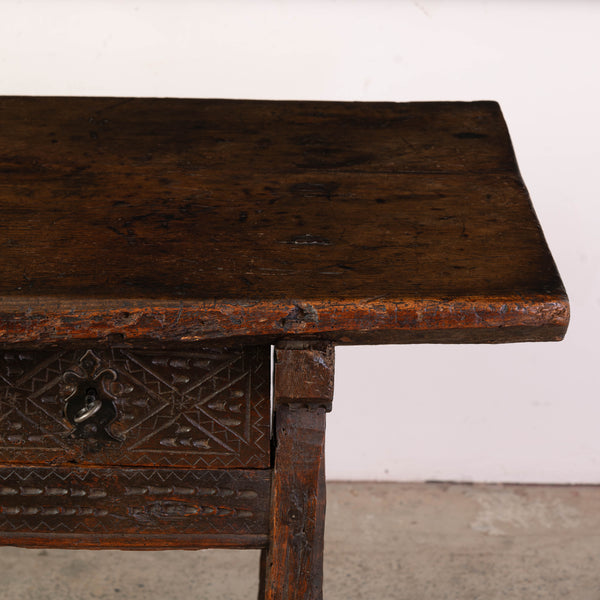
[0,97,569,345]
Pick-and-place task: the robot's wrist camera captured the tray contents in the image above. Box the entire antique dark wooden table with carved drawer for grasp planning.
[0,97,569,600]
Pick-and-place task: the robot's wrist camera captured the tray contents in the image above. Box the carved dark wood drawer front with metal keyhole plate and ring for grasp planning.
[0,347,270,468]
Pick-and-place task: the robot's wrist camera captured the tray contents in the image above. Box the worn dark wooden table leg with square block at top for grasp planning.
[260,346,334,600]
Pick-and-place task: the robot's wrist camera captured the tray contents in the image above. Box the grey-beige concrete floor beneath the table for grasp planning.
[0,483,600,600]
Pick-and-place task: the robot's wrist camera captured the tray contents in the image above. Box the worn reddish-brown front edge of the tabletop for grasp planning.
[0,291,570,345]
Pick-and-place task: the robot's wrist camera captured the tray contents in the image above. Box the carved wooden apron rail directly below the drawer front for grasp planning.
[0,467,271,535]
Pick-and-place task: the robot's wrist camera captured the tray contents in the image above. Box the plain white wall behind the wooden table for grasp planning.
[0,0,600,483]
